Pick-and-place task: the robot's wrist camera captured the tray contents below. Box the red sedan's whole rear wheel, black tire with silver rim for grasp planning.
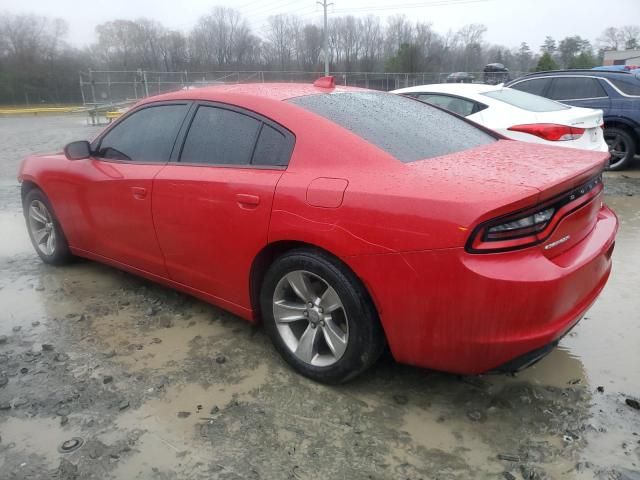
[260,248,385,384]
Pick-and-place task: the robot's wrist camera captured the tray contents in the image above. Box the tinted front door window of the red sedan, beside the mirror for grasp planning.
[95,104,188,163]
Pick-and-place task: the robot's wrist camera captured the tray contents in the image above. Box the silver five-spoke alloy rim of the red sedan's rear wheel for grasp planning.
[273,270,349,367]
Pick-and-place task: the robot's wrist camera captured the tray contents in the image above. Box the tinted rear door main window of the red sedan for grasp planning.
[180,105,261,165]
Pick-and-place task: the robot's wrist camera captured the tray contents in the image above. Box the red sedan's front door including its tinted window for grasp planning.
[69,103,188,276]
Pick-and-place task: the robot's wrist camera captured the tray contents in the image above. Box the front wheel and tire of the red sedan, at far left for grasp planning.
[22,188,72,265]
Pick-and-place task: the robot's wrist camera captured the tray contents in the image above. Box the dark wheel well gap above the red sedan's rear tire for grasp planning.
[249,240,378,322]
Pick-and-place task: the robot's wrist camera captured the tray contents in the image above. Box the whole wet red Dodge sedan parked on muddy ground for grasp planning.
[19,78,618,382]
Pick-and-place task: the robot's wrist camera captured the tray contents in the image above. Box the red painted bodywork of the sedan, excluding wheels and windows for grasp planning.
[19,79,617,374]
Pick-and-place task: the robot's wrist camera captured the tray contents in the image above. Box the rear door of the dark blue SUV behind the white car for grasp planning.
[547,76,610,110]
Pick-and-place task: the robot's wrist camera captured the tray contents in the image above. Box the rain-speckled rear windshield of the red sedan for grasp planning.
[288,92,496,162]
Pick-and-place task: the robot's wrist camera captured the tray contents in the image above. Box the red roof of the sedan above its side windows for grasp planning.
[135,83,364,103]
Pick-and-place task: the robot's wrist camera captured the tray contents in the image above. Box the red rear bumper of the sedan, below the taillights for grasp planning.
[349,202,618,374]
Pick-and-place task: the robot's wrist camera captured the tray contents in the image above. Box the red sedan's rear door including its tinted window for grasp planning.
[153,103,294,309]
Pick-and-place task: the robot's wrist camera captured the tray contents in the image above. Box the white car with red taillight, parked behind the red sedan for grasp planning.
[391,83,609,152]
